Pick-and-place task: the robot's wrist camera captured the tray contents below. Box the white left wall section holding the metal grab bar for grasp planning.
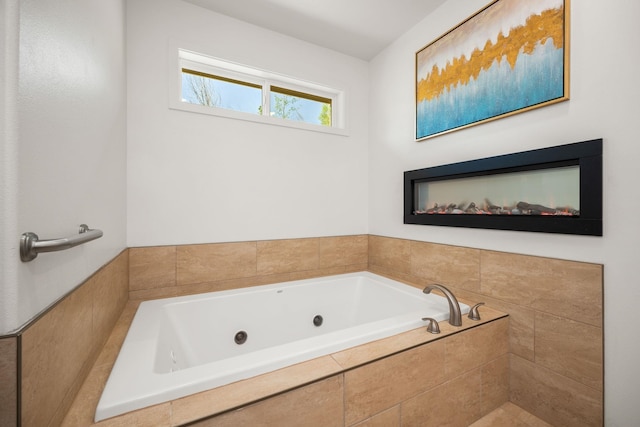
[0,0,126,334]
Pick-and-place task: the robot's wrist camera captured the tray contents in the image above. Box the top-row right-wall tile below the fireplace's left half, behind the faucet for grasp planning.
[411,242,480,291]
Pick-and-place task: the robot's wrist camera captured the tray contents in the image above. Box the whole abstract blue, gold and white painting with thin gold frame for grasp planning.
[415,0,570,141]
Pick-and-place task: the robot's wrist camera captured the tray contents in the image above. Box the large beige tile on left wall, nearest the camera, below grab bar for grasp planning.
[21,280,93,426]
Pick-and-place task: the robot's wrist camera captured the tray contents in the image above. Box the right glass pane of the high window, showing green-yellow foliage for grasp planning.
[270,86,331,127]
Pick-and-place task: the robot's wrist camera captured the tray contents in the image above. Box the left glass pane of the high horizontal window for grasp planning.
[182,70,262,114]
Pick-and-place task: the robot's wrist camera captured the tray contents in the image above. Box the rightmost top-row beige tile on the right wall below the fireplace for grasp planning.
[481,251,602,326]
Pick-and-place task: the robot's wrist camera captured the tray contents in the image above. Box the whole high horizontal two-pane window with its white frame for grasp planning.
[172,50,344,133]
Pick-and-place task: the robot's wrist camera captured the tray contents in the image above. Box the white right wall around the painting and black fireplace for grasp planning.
[369,0,640,427]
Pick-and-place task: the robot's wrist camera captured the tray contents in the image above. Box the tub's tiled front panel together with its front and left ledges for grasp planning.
[63,301,509,427]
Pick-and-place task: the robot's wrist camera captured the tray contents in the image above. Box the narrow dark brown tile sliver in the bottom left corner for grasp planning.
[0,337,18,427]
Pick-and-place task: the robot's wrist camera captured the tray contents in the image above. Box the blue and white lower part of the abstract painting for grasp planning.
[416,40,564,138]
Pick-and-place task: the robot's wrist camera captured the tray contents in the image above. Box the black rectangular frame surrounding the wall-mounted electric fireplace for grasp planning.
[404,138,603,236]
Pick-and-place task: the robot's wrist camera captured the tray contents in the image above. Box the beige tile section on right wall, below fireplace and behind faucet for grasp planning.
[369,236,603,427]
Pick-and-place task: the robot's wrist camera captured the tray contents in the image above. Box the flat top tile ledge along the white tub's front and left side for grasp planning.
[62,286,507,427]
